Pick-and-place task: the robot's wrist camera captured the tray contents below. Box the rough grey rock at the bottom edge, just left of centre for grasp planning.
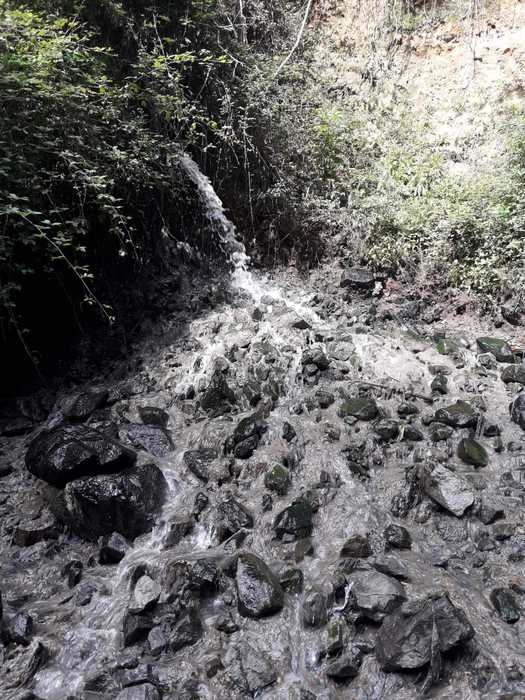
[224,641,278,697]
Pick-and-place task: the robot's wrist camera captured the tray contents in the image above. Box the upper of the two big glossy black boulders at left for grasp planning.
[25,425,136,488]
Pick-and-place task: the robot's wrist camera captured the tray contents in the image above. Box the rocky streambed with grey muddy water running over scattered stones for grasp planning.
[0,258,525,700]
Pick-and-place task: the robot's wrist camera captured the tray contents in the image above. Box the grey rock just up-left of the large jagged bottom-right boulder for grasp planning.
[348,571,406,622]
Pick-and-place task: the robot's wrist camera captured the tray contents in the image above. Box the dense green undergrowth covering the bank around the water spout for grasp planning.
[0,0,525,388]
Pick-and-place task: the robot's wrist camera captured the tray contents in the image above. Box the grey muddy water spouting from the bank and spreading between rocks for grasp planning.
[2,162,525,700]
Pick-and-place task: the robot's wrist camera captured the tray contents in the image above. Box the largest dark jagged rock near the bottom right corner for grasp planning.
[376,595,474,671]
